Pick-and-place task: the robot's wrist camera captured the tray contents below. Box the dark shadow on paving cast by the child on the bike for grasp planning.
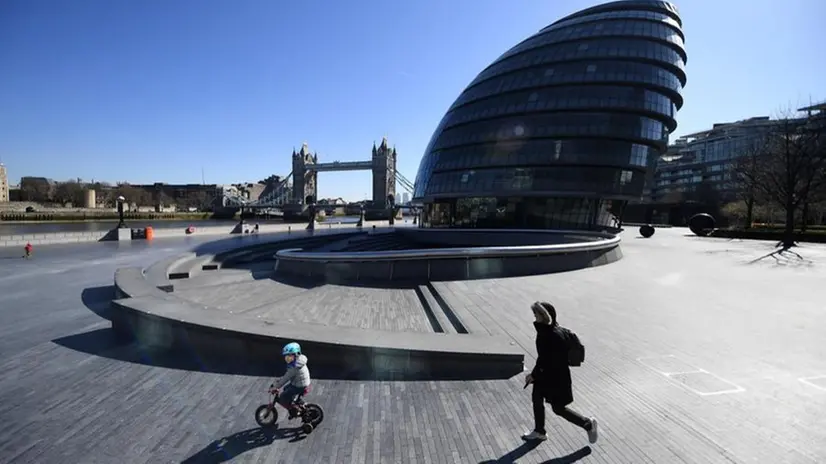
[182,427,303,464]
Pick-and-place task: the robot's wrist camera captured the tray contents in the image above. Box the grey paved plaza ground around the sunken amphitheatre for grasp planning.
[0,229,826,464]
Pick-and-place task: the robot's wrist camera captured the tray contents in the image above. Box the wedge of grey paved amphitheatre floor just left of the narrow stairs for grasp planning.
[238,284,437,332]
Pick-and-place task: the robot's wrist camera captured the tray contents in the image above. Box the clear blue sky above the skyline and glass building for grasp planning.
[0,0,826,200]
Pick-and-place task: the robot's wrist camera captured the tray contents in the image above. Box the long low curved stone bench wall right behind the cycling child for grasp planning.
[112,294,524,380]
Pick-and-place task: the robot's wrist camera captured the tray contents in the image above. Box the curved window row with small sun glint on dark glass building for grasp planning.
[433,113,668,150]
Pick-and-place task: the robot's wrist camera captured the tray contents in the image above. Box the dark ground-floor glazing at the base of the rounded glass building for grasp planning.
[422,197,625,230]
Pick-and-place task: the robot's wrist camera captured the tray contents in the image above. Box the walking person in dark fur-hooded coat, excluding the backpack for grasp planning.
[522,301,598,443]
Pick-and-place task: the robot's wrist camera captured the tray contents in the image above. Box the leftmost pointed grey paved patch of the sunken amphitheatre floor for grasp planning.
[175,279,307,313]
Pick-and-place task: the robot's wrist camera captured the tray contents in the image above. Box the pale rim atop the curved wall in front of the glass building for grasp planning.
[275,232,621,261]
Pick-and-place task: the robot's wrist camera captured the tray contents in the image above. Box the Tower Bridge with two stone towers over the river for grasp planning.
[216,137,413,216]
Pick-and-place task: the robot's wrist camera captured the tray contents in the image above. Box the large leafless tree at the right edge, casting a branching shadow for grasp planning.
[735,108,826,249]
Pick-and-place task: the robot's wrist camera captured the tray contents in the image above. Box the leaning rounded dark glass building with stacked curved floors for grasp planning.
[413,0,687,229]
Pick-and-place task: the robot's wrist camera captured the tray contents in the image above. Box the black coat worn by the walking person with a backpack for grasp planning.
[531,322,574,406]
